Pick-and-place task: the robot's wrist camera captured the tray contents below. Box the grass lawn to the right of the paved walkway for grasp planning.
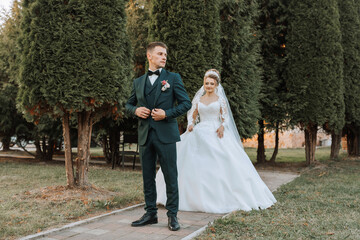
[197,159,360,239]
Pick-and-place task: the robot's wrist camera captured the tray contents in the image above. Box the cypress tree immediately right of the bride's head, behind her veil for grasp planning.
[220,0,262,138]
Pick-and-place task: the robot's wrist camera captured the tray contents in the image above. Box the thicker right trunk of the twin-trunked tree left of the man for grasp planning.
[76,111,92,188]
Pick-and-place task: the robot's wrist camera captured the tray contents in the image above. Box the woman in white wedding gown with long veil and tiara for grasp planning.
[156,69,276,213]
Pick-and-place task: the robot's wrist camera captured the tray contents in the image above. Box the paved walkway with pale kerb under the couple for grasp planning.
[22,171,298,240]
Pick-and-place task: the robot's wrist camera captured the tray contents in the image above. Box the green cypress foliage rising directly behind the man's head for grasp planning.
[149,0,221,97]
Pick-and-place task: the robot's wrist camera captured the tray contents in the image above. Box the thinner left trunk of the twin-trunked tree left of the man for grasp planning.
[62,112,75,188]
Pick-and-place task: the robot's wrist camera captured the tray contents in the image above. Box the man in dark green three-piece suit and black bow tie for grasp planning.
[126,42,191,231]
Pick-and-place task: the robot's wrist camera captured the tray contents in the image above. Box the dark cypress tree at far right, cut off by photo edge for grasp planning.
[338,0,360,158]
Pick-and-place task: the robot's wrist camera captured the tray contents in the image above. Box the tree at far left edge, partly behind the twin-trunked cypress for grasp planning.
[0,1,61,158]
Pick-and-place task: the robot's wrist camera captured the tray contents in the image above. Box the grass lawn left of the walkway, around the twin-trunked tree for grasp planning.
[0,162,143,239]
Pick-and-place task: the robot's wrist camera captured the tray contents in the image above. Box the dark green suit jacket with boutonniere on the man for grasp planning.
[125,69,191,145]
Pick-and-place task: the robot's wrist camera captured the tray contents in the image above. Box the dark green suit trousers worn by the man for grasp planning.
[139,128,179,217]
